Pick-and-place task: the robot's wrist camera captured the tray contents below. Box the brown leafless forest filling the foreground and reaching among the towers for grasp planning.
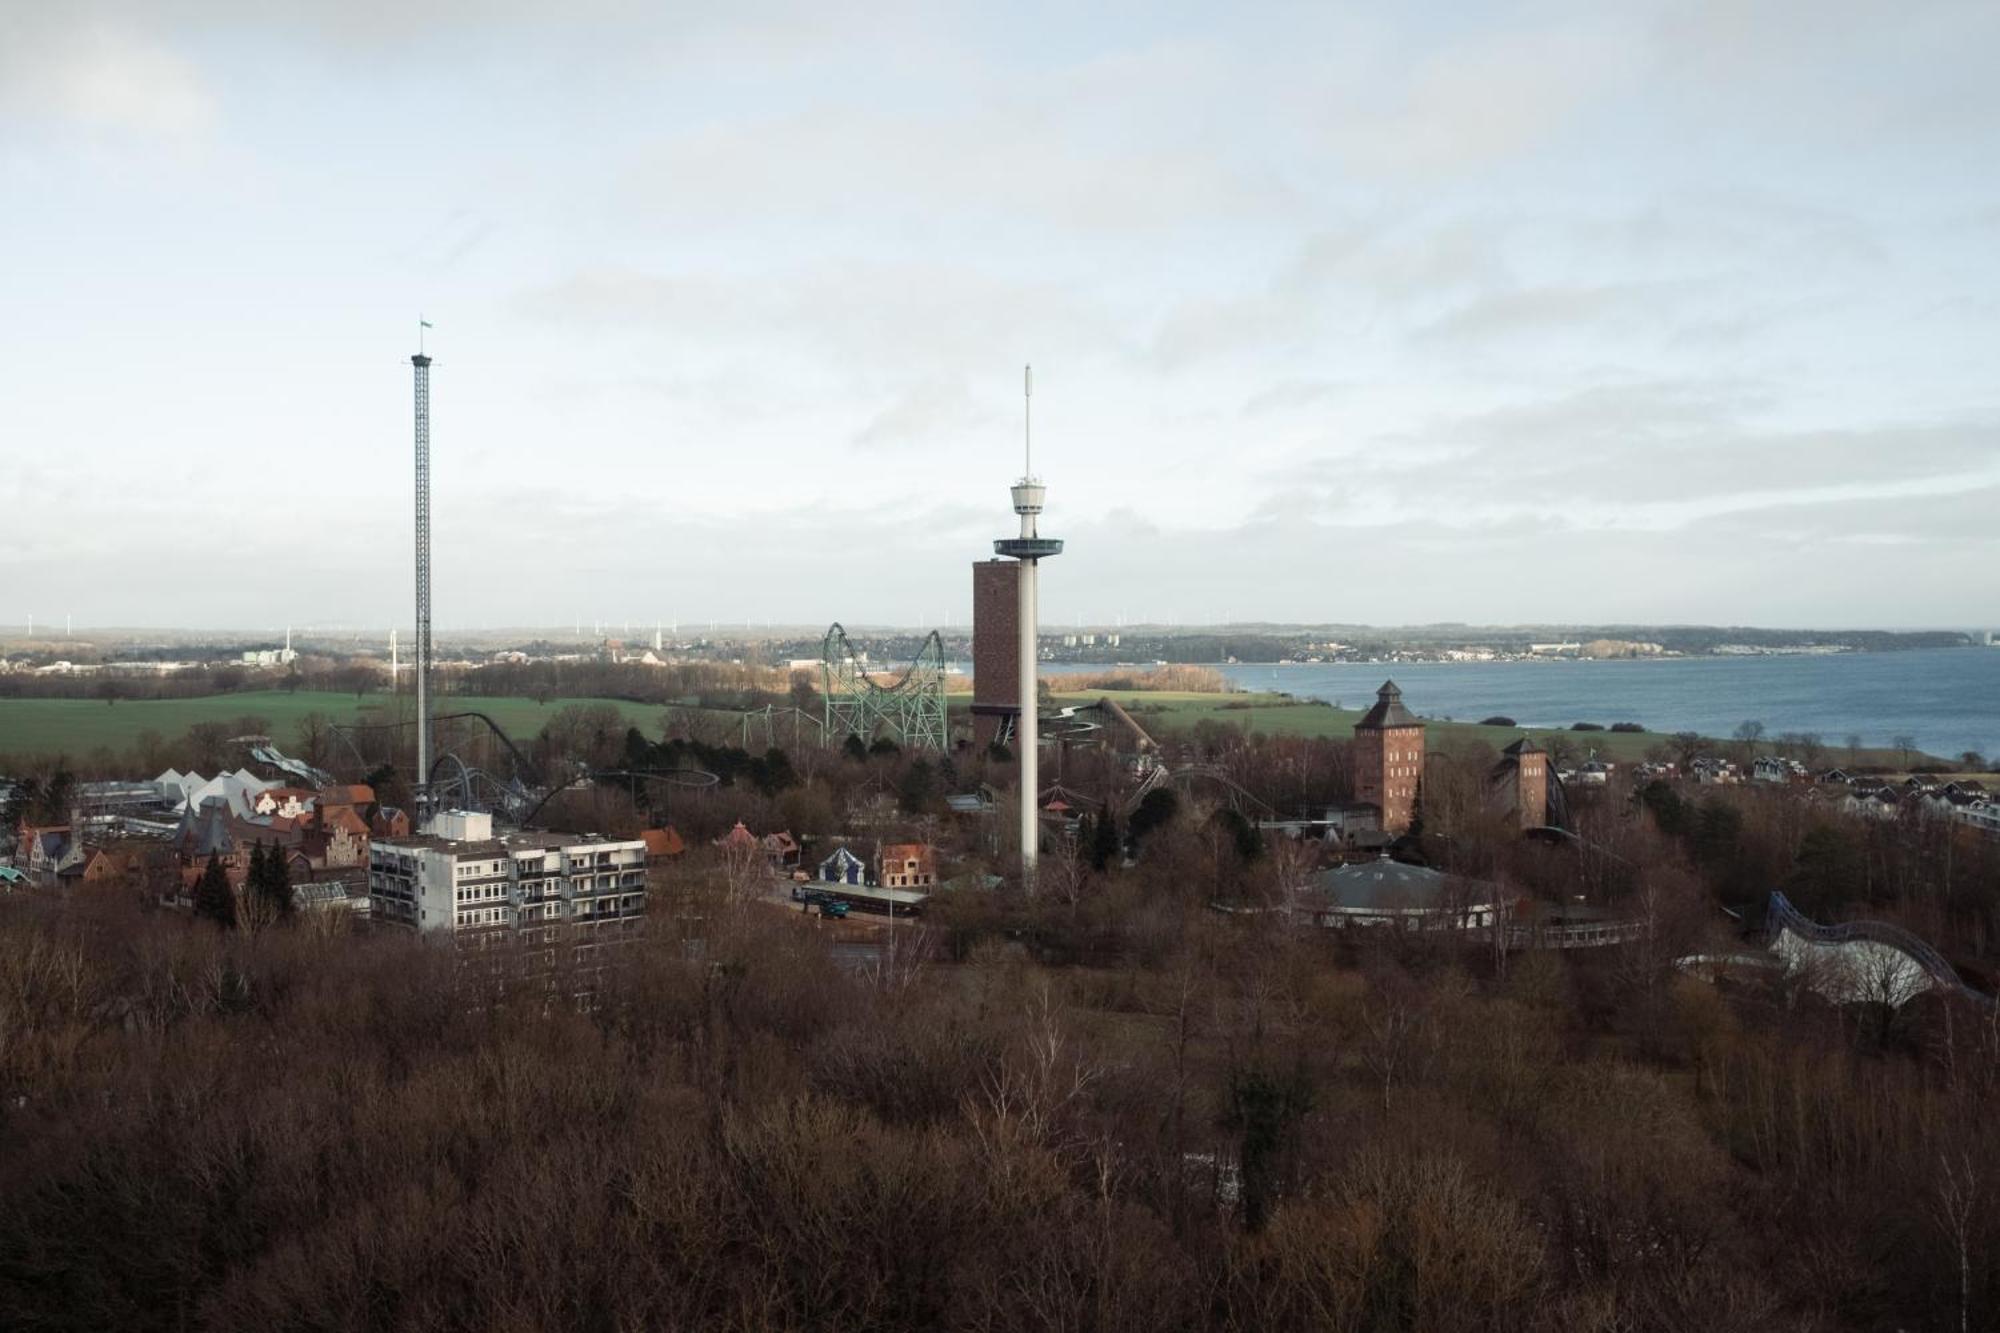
[0,704,2000,1333]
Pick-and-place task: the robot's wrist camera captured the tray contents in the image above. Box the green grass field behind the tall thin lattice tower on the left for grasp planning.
[0,691,666,759]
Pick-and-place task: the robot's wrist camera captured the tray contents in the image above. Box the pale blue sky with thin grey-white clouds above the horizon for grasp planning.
[0,0,2000,630]
